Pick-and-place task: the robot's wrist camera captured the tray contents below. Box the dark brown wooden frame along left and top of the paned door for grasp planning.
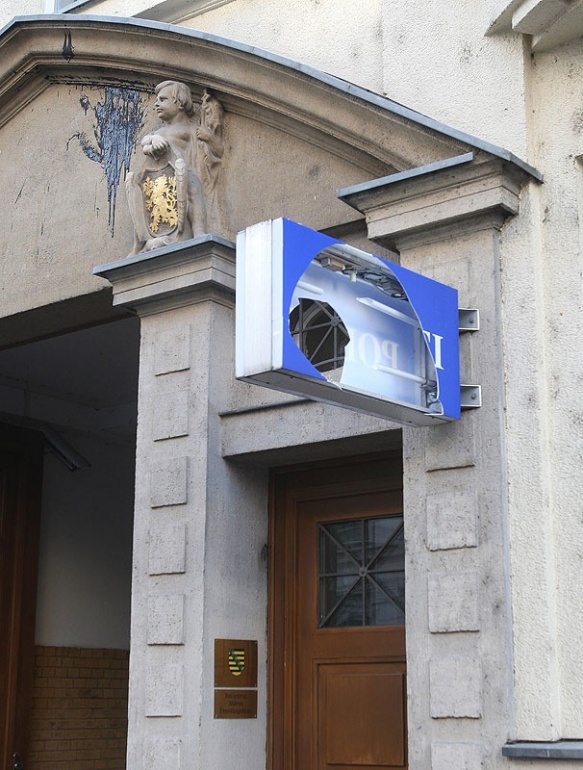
[267,451,403,770]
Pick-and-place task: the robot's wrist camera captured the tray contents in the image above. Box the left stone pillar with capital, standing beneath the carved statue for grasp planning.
[95,236,266,770]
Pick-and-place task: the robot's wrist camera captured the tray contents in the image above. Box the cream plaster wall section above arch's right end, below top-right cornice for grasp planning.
[382,0,528,159]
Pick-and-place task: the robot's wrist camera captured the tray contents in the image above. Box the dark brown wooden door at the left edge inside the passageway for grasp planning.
[0,426,43,770]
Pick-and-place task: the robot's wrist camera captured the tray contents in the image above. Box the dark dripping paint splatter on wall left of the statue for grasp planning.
[75,87,144,237]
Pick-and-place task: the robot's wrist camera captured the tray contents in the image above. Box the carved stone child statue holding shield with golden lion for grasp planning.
[126,80,223,256]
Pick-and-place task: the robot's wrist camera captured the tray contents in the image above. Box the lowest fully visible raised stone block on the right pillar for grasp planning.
[429,654,482,716]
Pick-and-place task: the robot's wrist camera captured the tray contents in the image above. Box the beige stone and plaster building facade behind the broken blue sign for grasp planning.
[0,0,583,770]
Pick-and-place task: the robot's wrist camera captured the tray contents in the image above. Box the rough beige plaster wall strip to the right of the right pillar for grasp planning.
[502,37,583,739]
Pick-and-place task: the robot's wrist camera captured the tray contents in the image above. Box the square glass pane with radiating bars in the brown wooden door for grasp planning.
[318,516,405,628]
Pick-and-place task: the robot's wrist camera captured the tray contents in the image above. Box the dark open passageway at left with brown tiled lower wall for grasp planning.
[0,318,139,770]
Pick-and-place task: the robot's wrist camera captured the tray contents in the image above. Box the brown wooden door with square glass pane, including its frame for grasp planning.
[270,457,407,770]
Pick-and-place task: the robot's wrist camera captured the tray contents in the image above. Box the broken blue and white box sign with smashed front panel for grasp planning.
[236,219,460,425]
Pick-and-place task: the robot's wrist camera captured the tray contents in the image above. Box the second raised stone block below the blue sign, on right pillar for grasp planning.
[426,488,478,551]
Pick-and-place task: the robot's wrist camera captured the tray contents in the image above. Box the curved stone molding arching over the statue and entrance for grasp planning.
[0,15,533,176]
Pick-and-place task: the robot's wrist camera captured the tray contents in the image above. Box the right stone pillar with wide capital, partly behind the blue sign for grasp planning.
[343,156,540,770]
